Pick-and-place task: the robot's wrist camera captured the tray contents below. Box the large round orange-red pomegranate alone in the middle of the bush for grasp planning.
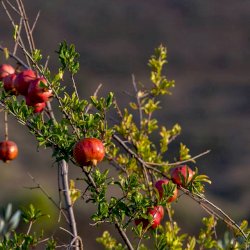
[73,138,105,166]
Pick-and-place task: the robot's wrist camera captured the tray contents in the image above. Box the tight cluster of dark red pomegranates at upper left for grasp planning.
[0,64,52,113]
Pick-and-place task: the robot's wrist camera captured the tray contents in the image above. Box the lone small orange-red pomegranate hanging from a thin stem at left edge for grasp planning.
[0,140,18,162]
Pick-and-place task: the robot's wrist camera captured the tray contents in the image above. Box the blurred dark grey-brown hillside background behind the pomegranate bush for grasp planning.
[0,0,250,249]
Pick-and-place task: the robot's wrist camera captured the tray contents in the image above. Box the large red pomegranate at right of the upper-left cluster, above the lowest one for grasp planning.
[28,78,52,103]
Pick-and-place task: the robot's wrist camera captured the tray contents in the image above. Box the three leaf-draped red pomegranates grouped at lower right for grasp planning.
[135,165,195,229]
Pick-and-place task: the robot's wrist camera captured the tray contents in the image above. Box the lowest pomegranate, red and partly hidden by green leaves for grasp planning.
[135,206,164,229]
